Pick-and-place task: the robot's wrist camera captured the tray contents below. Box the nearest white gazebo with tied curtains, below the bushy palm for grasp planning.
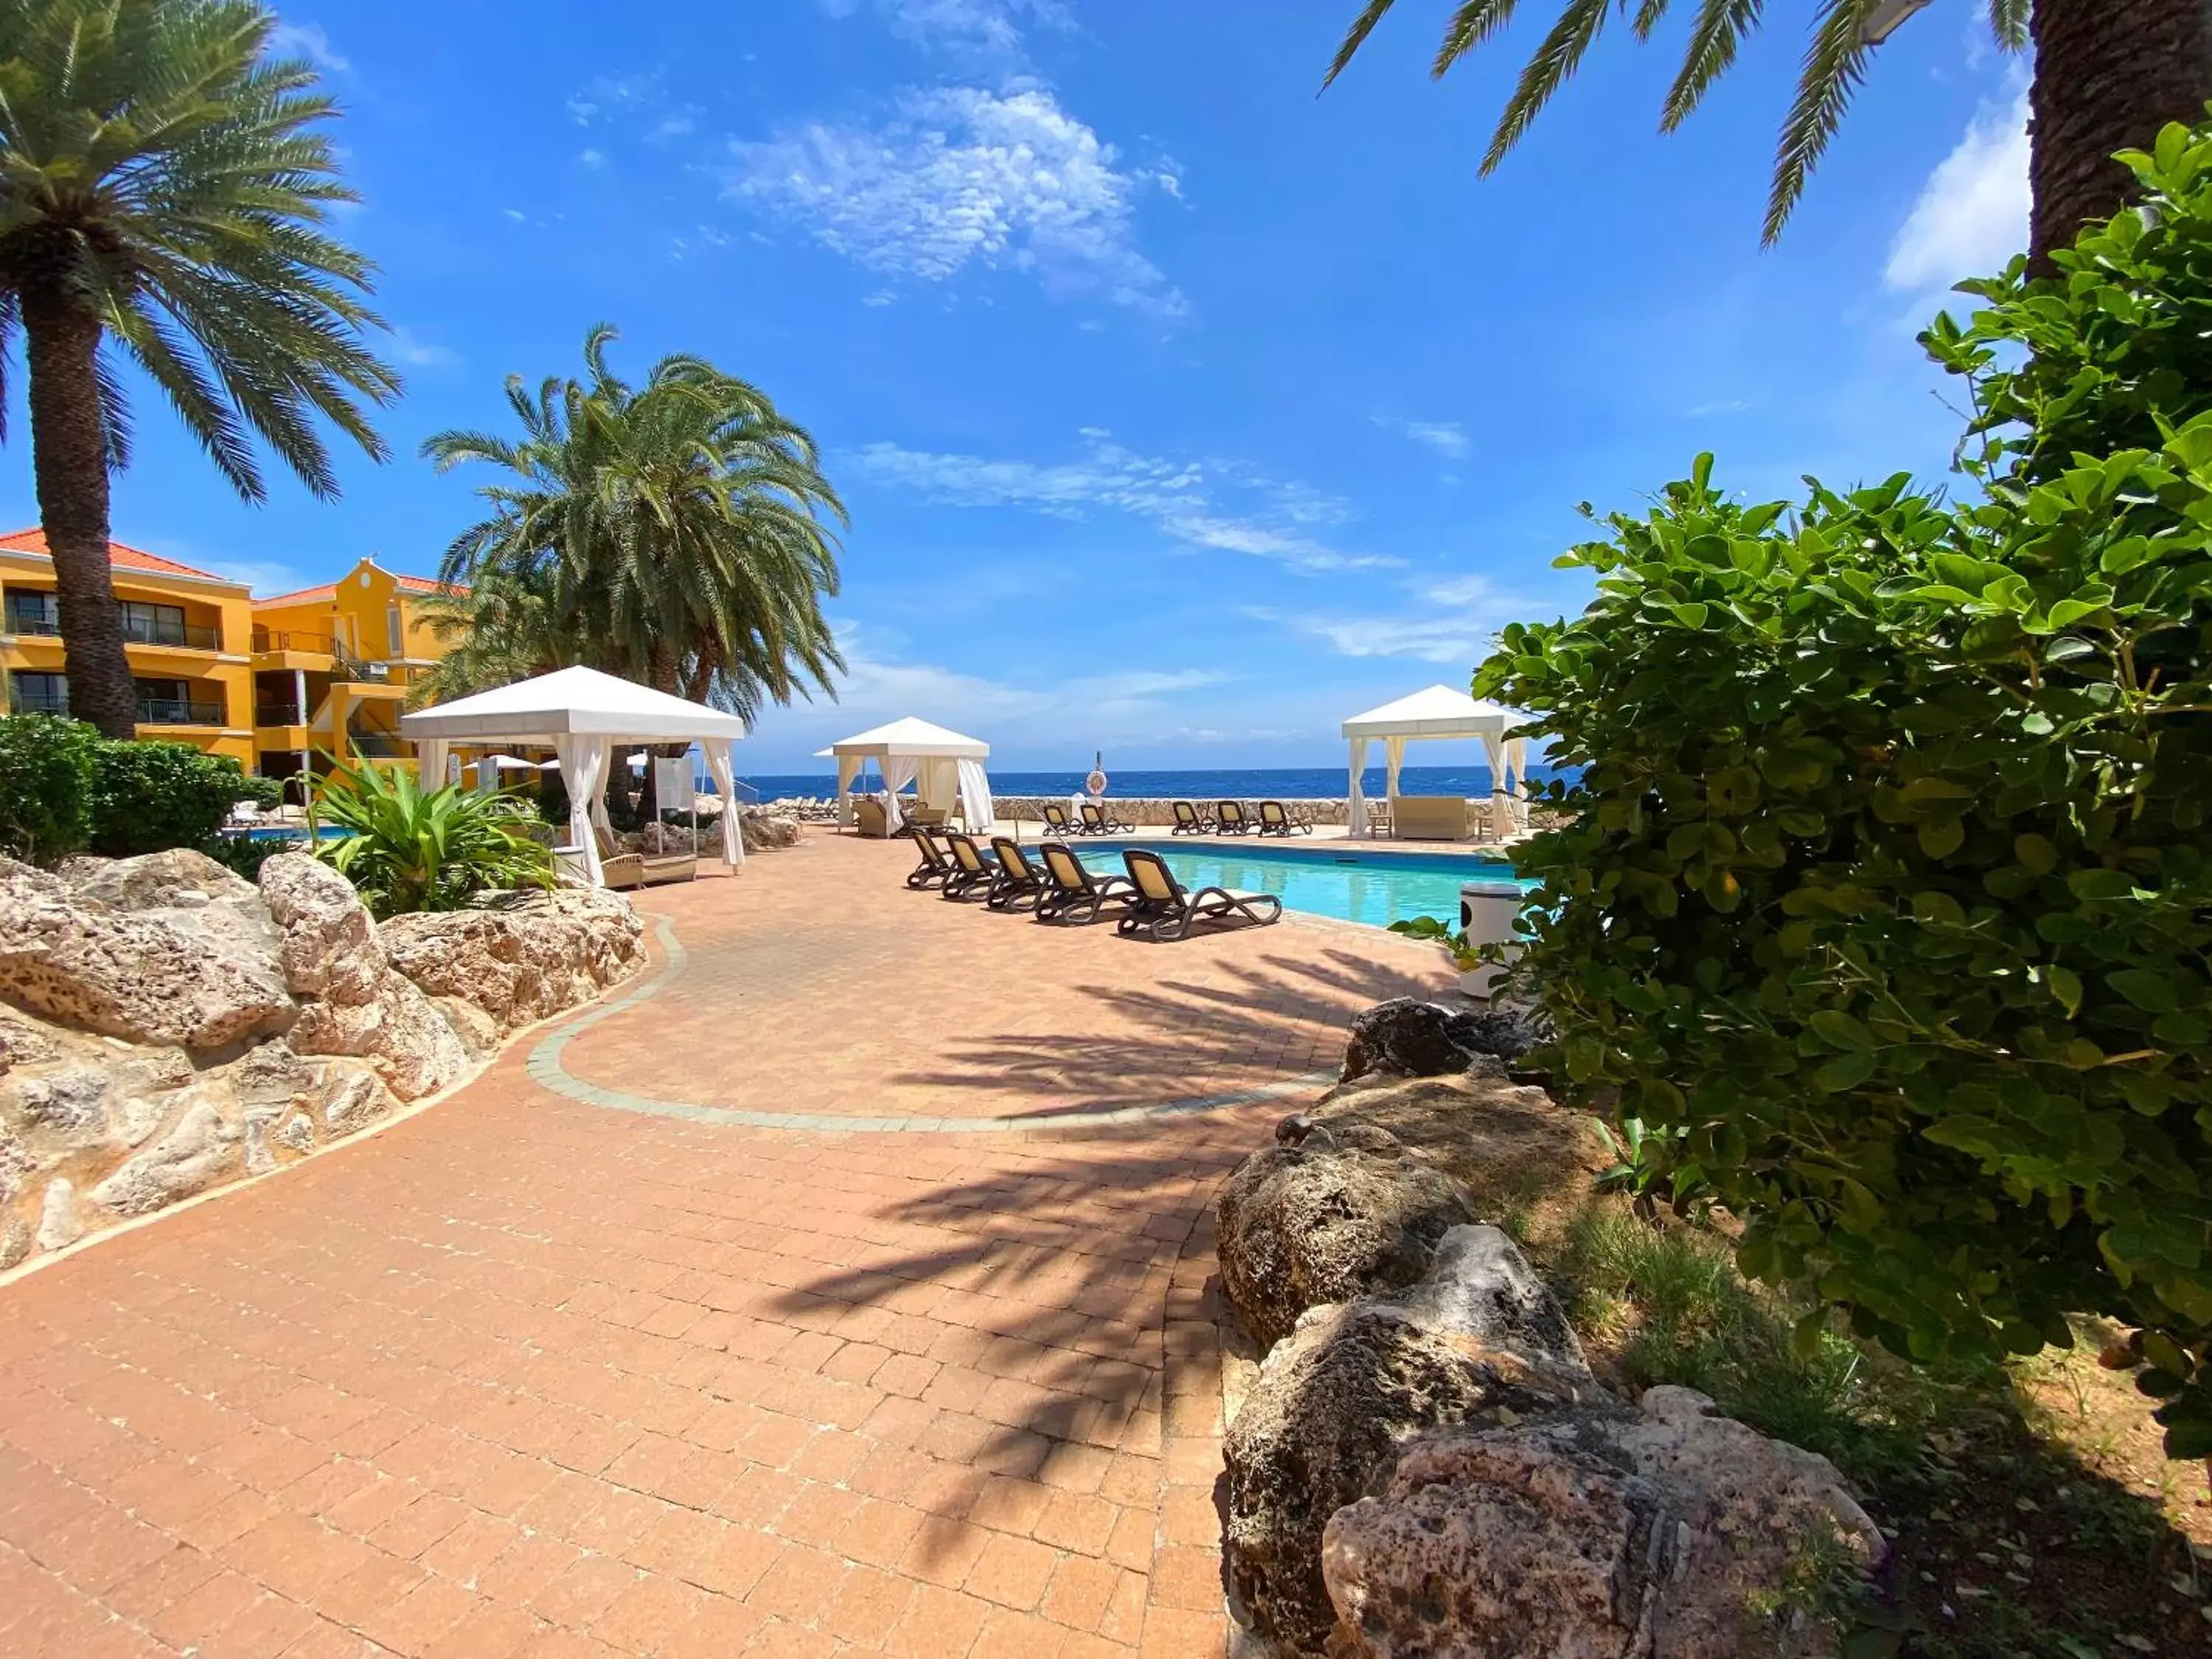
[400,668,745,887]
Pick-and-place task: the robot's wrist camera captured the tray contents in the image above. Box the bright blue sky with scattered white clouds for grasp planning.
[0,0,2026,772]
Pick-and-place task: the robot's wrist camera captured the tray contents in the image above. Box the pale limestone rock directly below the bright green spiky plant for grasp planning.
[378,889,646,1031]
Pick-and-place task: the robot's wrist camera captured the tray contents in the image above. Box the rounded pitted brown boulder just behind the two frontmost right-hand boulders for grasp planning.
[1214,1119,1473,1347]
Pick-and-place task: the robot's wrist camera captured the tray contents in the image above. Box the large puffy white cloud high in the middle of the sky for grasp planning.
[726,86,1186,319]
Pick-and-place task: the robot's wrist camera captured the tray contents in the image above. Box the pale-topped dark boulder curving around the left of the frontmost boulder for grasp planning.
[1223,1303,1595,1652]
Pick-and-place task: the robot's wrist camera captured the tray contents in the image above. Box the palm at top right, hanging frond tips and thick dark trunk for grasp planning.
[1323,0,2212,263]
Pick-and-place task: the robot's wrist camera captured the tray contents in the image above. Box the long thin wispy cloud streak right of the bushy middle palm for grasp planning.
[854,427,1396,573]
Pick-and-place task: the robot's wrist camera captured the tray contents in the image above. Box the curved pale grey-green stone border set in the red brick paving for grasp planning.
[526,916,1336,1135]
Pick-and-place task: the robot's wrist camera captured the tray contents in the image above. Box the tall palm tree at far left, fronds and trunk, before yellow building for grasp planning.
[0,0,398,737]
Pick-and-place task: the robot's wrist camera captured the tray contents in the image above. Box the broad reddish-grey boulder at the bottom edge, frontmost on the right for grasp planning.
[1321,1387,1885,1659]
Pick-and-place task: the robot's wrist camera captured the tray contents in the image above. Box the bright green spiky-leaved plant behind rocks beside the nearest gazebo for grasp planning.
[314,761,553,918]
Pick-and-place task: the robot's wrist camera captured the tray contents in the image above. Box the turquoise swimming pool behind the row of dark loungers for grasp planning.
[1073,841,1535,927]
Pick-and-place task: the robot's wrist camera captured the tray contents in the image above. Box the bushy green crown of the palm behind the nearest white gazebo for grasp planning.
[422,323,847,814]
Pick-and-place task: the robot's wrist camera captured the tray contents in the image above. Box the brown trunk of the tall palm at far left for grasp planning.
[22,285,137,739]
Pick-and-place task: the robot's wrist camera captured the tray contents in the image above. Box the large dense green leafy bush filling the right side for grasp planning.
[1475,128,2212,1458]
